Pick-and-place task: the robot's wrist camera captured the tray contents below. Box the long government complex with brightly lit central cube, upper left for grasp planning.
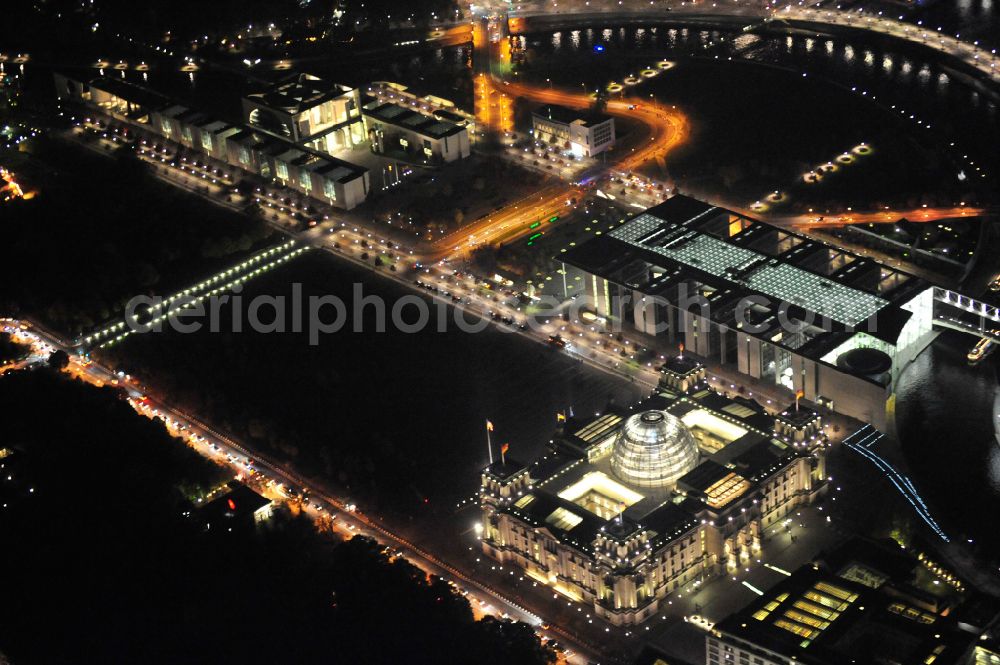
[55,74,470,210]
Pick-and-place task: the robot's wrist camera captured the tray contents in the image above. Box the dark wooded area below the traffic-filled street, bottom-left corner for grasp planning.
[0,370,553,665]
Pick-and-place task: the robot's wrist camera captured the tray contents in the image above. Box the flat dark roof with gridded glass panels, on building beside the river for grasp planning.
[557,196,929,360]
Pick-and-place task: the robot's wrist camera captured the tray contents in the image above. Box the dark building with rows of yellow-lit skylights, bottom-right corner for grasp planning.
[705,540,997,665]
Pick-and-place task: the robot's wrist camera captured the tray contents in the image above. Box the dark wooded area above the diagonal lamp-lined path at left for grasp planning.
[0,139,272,334]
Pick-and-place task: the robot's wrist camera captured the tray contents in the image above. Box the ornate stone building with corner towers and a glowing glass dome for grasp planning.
[480,357,827,625]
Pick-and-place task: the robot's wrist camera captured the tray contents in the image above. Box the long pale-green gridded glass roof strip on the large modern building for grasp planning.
[609,213,889,326]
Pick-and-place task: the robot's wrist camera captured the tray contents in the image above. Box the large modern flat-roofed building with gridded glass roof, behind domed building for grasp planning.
[564,196,940,427]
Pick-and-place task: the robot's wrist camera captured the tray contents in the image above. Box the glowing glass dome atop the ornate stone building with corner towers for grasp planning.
[611,411,698,487]
